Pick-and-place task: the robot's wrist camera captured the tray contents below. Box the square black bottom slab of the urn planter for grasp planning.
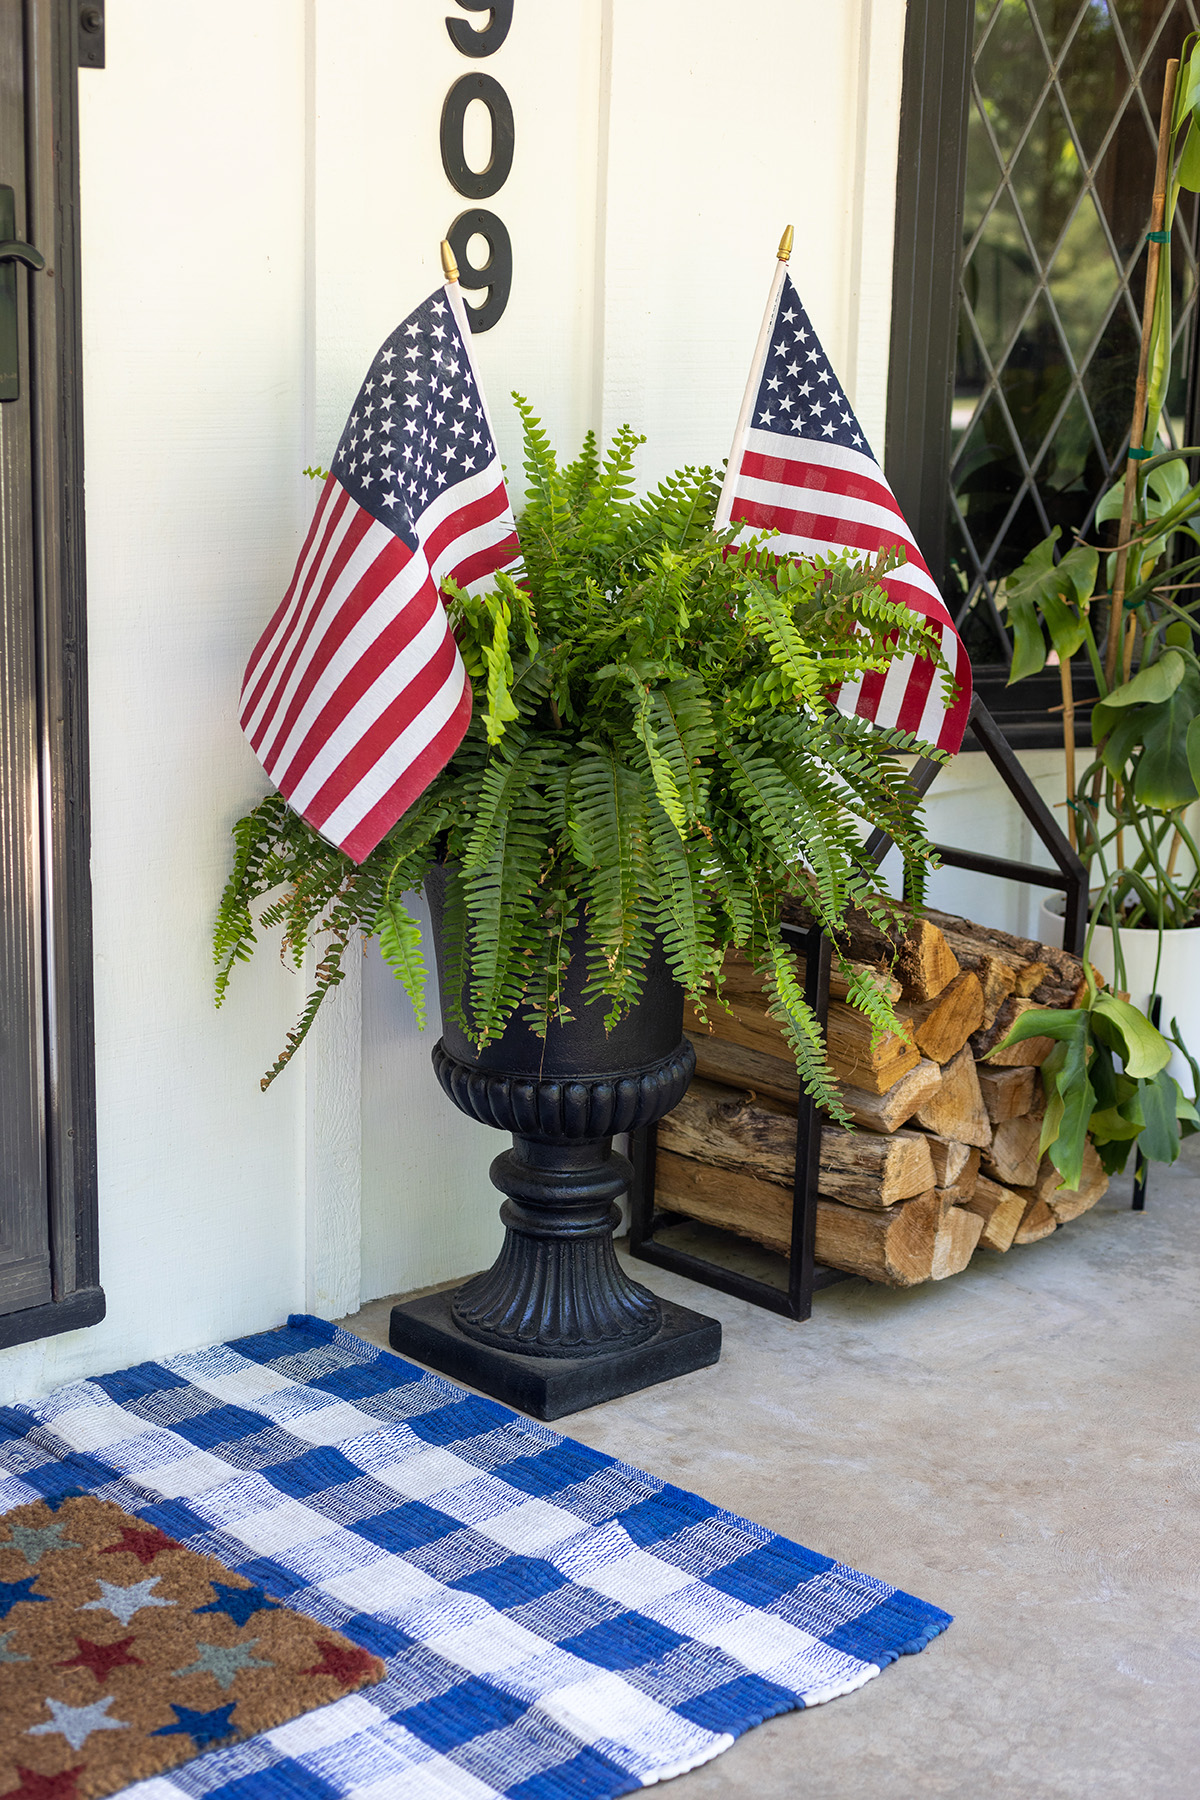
[389,1289,721,1418]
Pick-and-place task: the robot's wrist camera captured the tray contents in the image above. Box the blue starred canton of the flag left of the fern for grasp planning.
[333,288,495,549]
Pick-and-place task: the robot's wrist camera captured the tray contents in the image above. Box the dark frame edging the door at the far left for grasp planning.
[0,0,104,1348]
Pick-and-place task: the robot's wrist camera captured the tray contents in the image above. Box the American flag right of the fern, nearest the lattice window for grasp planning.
[716,263,972,752]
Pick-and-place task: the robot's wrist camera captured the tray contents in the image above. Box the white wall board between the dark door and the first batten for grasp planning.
[0,0,314,1399]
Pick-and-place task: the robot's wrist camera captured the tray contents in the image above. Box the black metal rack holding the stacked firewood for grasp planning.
[630,697,1088,1319]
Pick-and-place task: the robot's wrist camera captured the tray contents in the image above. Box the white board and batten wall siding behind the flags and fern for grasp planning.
[0,0,1036,1400]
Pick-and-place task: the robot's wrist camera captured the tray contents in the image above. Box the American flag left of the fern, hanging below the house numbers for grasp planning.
[241,283,520,862]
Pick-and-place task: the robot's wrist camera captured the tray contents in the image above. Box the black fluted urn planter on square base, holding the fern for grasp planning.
[390,868,721,1418]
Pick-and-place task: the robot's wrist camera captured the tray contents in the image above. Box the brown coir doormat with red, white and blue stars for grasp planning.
[0,1494,383,1800]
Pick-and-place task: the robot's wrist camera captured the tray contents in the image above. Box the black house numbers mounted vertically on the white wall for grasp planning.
[439,0,515,331]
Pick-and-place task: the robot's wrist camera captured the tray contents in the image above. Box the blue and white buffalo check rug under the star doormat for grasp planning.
[0,1318,950,1800]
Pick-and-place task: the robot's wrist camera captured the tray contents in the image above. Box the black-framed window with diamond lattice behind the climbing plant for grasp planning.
[889,0,1200,743]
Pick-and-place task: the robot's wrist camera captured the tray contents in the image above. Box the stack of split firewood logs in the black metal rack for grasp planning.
[655,905,1108,1287]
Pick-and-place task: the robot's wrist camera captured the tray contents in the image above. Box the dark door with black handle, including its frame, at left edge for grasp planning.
[0,0,104,1345]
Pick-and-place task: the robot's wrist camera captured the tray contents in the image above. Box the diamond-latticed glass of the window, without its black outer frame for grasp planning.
[946,0,1200,650]
